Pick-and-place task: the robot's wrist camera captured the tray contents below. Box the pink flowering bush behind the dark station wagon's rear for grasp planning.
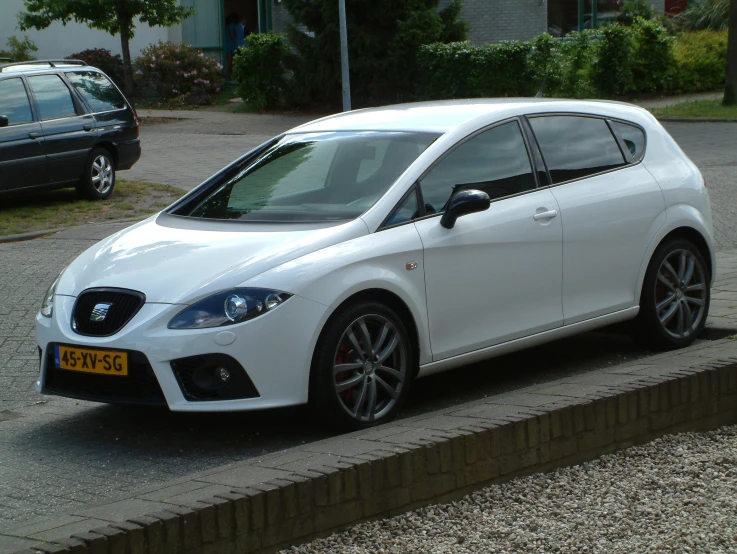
[134,41,225,99]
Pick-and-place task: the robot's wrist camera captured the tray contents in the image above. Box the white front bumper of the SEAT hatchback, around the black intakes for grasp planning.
[36,296,330,411]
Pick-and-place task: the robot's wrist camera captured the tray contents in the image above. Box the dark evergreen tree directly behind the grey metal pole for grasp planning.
[284,0,467,107]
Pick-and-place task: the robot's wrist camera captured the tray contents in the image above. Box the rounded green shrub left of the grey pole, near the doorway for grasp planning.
[233,32,290,110]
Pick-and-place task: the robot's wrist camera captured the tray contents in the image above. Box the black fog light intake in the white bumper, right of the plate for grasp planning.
[171,354,259,402]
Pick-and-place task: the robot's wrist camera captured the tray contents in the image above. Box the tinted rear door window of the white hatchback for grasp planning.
[530,115,624,184]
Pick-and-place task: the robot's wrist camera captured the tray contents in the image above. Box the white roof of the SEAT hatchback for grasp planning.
[288,98,647,134]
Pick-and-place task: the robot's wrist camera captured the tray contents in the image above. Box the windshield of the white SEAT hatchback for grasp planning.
[183,131,437,222]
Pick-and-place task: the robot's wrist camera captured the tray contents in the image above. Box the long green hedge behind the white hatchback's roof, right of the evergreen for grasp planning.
[418,17,727,99]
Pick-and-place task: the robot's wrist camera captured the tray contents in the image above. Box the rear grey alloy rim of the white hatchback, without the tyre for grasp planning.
[655,249,707,339]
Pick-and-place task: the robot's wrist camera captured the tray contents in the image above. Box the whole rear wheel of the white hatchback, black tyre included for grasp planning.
[633,239,711,350]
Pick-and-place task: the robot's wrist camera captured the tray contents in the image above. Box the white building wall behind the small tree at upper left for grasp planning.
[0,0,182,59]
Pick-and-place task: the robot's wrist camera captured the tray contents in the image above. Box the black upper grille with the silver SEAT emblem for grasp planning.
[72,289,146,337]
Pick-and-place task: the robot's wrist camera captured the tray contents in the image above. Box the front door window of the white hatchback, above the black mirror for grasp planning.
[422,121,535,213]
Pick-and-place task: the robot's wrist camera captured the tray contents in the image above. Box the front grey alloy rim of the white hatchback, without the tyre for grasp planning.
[333,314,408,422]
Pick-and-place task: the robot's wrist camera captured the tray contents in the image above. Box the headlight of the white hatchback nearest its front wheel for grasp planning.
[168,289,292,329]
